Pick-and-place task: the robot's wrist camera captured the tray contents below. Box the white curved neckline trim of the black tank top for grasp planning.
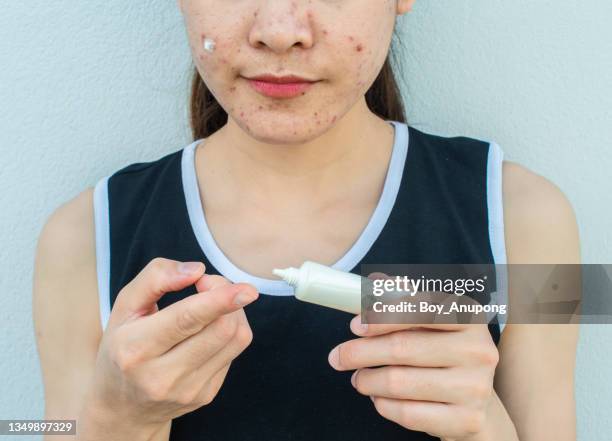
[181,120,409,296]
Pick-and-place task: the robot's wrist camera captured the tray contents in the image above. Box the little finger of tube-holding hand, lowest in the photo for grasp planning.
[372,396,480,437]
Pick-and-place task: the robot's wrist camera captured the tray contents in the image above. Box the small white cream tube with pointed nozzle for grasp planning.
[272,260,368,314]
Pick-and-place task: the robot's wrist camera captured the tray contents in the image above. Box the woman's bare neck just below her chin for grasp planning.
[198,98,393,207]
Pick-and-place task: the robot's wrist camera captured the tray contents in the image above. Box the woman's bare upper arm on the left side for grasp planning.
[32,188,102,430]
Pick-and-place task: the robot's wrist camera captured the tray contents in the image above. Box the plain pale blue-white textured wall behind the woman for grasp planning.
[0,0,612,441]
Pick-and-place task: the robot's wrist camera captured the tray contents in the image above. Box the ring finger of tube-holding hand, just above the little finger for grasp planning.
[351,366,480,403]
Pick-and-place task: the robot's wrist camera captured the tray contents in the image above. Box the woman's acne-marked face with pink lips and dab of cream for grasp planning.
[179,0,414,142]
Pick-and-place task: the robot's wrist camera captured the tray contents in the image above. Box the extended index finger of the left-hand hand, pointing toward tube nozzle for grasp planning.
[127,283,259,359]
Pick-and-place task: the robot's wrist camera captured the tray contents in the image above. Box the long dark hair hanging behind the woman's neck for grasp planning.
[189,29,406,140]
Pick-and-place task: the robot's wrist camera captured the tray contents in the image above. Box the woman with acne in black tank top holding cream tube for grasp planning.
[34,0,579,441]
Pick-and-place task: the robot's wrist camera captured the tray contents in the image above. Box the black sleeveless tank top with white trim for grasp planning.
[94,121,506,441]
